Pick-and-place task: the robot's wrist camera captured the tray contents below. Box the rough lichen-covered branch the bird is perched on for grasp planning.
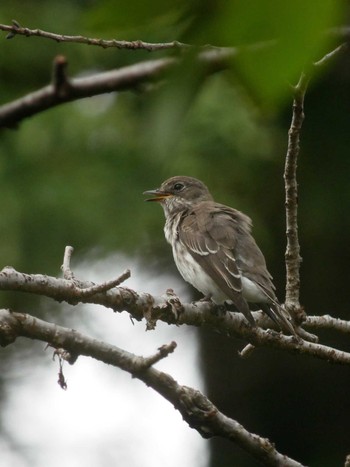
[0,267,350,365]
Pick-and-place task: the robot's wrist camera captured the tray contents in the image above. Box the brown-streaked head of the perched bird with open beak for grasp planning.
[144,176,213,214]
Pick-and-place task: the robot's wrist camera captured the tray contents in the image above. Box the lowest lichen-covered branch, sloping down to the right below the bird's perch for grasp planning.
[0,310,302,467]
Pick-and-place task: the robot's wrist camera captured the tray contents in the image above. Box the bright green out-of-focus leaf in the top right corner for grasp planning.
[186,0,342,107]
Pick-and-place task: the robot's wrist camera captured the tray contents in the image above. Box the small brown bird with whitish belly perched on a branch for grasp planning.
[144,176,296,335]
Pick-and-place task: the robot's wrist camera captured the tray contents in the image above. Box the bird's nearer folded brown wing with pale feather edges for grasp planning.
[178,202,254,324]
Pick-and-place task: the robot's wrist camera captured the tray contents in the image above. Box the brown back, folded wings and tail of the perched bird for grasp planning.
[178,202,295,334]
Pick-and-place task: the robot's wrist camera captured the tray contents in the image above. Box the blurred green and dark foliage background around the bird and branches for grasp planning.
[0,0,350,467]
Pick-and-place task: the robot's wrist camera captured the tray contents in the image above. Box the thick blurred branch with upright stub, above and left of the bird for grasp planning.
[0,49,236,128]
